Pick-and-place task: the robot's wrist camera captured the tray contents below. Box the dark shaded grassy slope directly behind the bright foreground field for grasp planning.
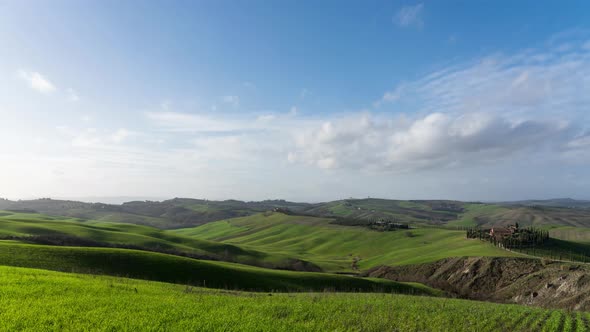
[0,241,439,295]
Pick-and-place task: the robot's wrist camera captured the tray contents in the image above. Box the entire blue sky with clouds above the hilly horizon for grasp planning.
[0,0,590,202]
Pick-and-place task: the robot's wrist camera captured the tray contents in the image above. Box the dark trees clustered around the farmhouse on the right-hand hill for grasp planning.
[466,223,549,249]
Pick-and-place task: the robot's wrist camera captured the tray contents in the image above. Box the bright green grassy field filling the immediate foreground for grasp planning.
[0,267,590,332]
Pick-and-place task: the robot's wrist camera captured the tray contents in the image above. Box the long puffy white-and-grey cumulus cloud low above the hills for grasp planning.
[288,113,570,171]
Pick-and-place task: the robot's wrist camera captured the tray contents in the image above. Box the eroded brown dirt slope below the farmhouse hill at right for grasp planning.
[365,257,590,311]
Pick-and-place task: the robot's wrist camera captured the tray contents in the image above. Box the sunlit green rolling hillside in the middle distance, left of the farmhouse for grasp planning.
[169,213,515,271]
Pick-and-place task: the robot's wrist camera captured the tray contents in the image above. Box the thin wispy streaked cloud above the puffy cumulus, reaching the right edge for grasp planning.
[374,38,590,118]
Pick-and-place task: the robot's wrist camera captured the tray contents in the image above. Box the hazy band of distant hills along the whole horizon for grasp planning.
[0,198,590,229]
